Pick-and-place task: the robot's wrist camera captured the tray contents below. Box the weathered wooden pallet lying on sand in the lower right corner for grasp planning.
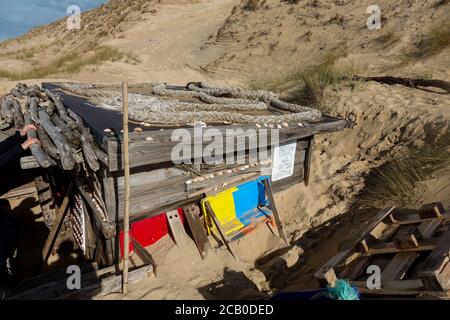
[314,203,450,298]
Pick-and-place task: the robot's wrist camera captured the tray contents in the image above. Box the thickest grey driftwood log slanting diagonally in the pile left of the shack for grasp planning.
[39,110,75,170]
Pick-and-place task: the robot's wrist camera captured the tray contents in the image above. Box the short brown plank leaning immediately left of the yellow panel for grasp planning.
[183,204,212,259]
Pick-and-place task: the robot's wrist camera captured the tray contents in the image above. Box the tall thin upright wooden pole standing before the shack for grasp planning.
[122,82,130,294]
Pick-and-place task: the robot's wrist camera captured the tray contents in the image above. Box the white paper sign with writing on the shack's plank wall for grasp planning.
[272,142,297,181]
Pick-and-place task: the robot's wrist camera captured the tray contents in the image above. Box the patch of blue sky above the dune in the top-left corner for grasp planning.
[0,0,108,41]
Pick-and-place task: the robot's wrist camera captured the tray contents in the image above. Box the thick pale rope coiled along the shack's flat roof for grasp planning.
[61,82,322,125]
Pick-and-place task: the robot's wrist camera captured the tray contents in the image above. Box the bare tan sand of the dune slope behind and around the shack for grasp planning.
[0,0,450,299]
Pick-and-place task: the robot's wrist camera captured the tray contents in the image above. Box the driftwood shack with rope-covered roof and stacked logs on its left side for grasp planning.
[2,83,350,298]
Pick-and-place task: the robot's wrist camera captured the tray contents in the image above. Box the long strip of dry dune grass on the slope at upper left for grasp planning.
[0,46,140,81]
